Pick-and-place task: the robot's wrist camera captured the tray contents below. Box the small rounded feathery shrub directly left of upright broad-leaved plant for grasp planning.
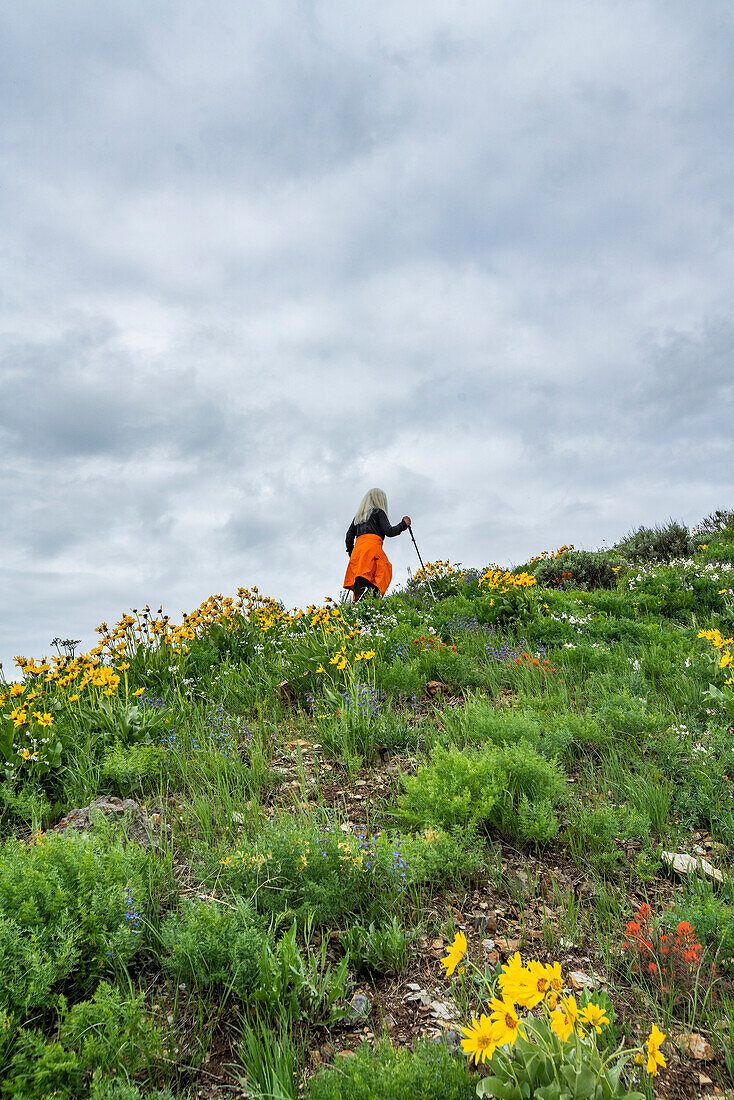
[161,898,267,998]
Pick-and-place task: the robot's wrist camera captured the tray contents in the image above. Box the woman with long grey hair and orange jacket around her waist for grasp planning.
[343,488,410,603]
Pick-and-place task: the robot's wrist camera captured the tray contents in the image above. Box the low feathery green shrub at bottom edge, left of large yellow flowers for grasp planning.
[306,1043,475,1100]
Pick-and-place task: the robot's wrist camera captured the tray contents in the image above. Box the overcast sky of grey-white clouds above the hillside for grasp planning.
[0,0,734,675]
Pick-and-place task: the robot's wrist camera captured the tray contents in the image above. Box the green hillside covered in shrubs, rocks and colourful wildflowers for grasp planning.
[0,513,734,1100]
